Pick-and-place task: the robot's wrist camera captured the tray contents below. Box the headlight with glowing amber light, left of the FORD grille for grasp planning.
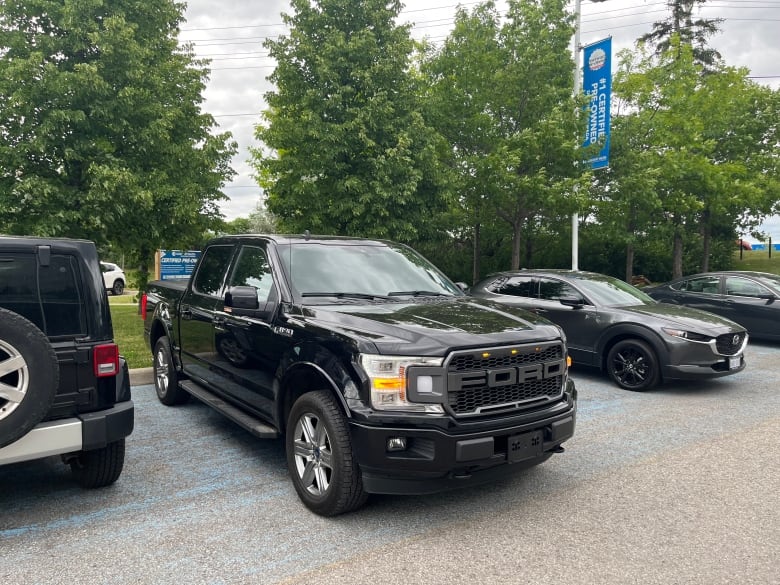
[360,354,444,414]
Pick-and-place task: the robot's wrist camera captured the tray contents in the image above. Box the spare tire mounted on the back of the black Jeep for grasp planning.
[0,309,60,447]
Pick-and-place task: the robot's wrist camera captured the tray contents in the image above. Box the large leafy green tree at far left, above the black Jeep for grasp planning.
[0,0,235,282]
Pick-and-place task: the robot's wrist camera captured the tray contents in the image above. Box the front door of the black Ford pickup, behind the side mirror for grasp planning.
[214,245,280,419]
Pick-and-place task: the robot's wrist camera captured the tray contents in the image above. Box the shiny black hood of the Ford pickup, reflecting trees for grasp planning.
[304,297,561,356]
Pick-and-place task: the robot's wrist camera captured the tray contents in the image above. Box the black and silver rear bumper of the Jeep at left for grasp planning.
[0,400,134,465]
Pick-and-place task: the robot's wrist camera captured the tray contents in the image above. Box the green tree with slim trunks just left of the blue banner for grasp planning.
[426,0,584,277]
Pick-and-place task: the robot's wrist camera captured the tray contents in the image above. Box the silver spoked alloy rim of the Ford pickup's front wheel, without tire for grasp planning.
[294,413,333,496]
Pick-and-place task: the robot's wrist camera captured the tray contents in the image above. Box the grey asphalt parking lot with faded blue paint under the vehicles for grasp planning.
[0,342,780,585]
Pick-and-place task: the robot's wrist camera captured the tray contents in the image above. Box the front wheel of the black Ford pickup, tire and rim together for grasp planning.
[285,390,368,516]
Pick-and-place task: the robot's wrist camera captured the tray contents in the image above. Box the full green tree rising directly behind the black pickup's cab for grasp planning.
[253,0,447,242]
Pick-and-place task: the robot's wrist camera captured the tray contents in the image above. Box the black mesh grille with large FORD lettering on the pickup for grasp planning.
[445,343,566,416]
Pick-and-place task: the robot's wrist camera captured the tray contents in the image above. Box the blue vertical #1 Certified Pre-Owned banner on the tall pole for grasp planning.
[582,37,612,169]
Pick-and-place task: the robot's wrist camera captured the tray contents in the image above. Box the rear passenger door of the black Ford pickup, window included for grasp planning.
[179,245,235,385]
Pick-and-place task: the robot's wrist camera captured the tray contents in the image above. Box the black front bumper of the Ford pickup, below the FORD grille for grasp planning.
[350,394,577,494]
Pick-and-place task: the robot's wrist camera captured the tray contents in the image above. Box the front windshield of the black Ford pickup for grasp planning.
[279,242,463,299]
